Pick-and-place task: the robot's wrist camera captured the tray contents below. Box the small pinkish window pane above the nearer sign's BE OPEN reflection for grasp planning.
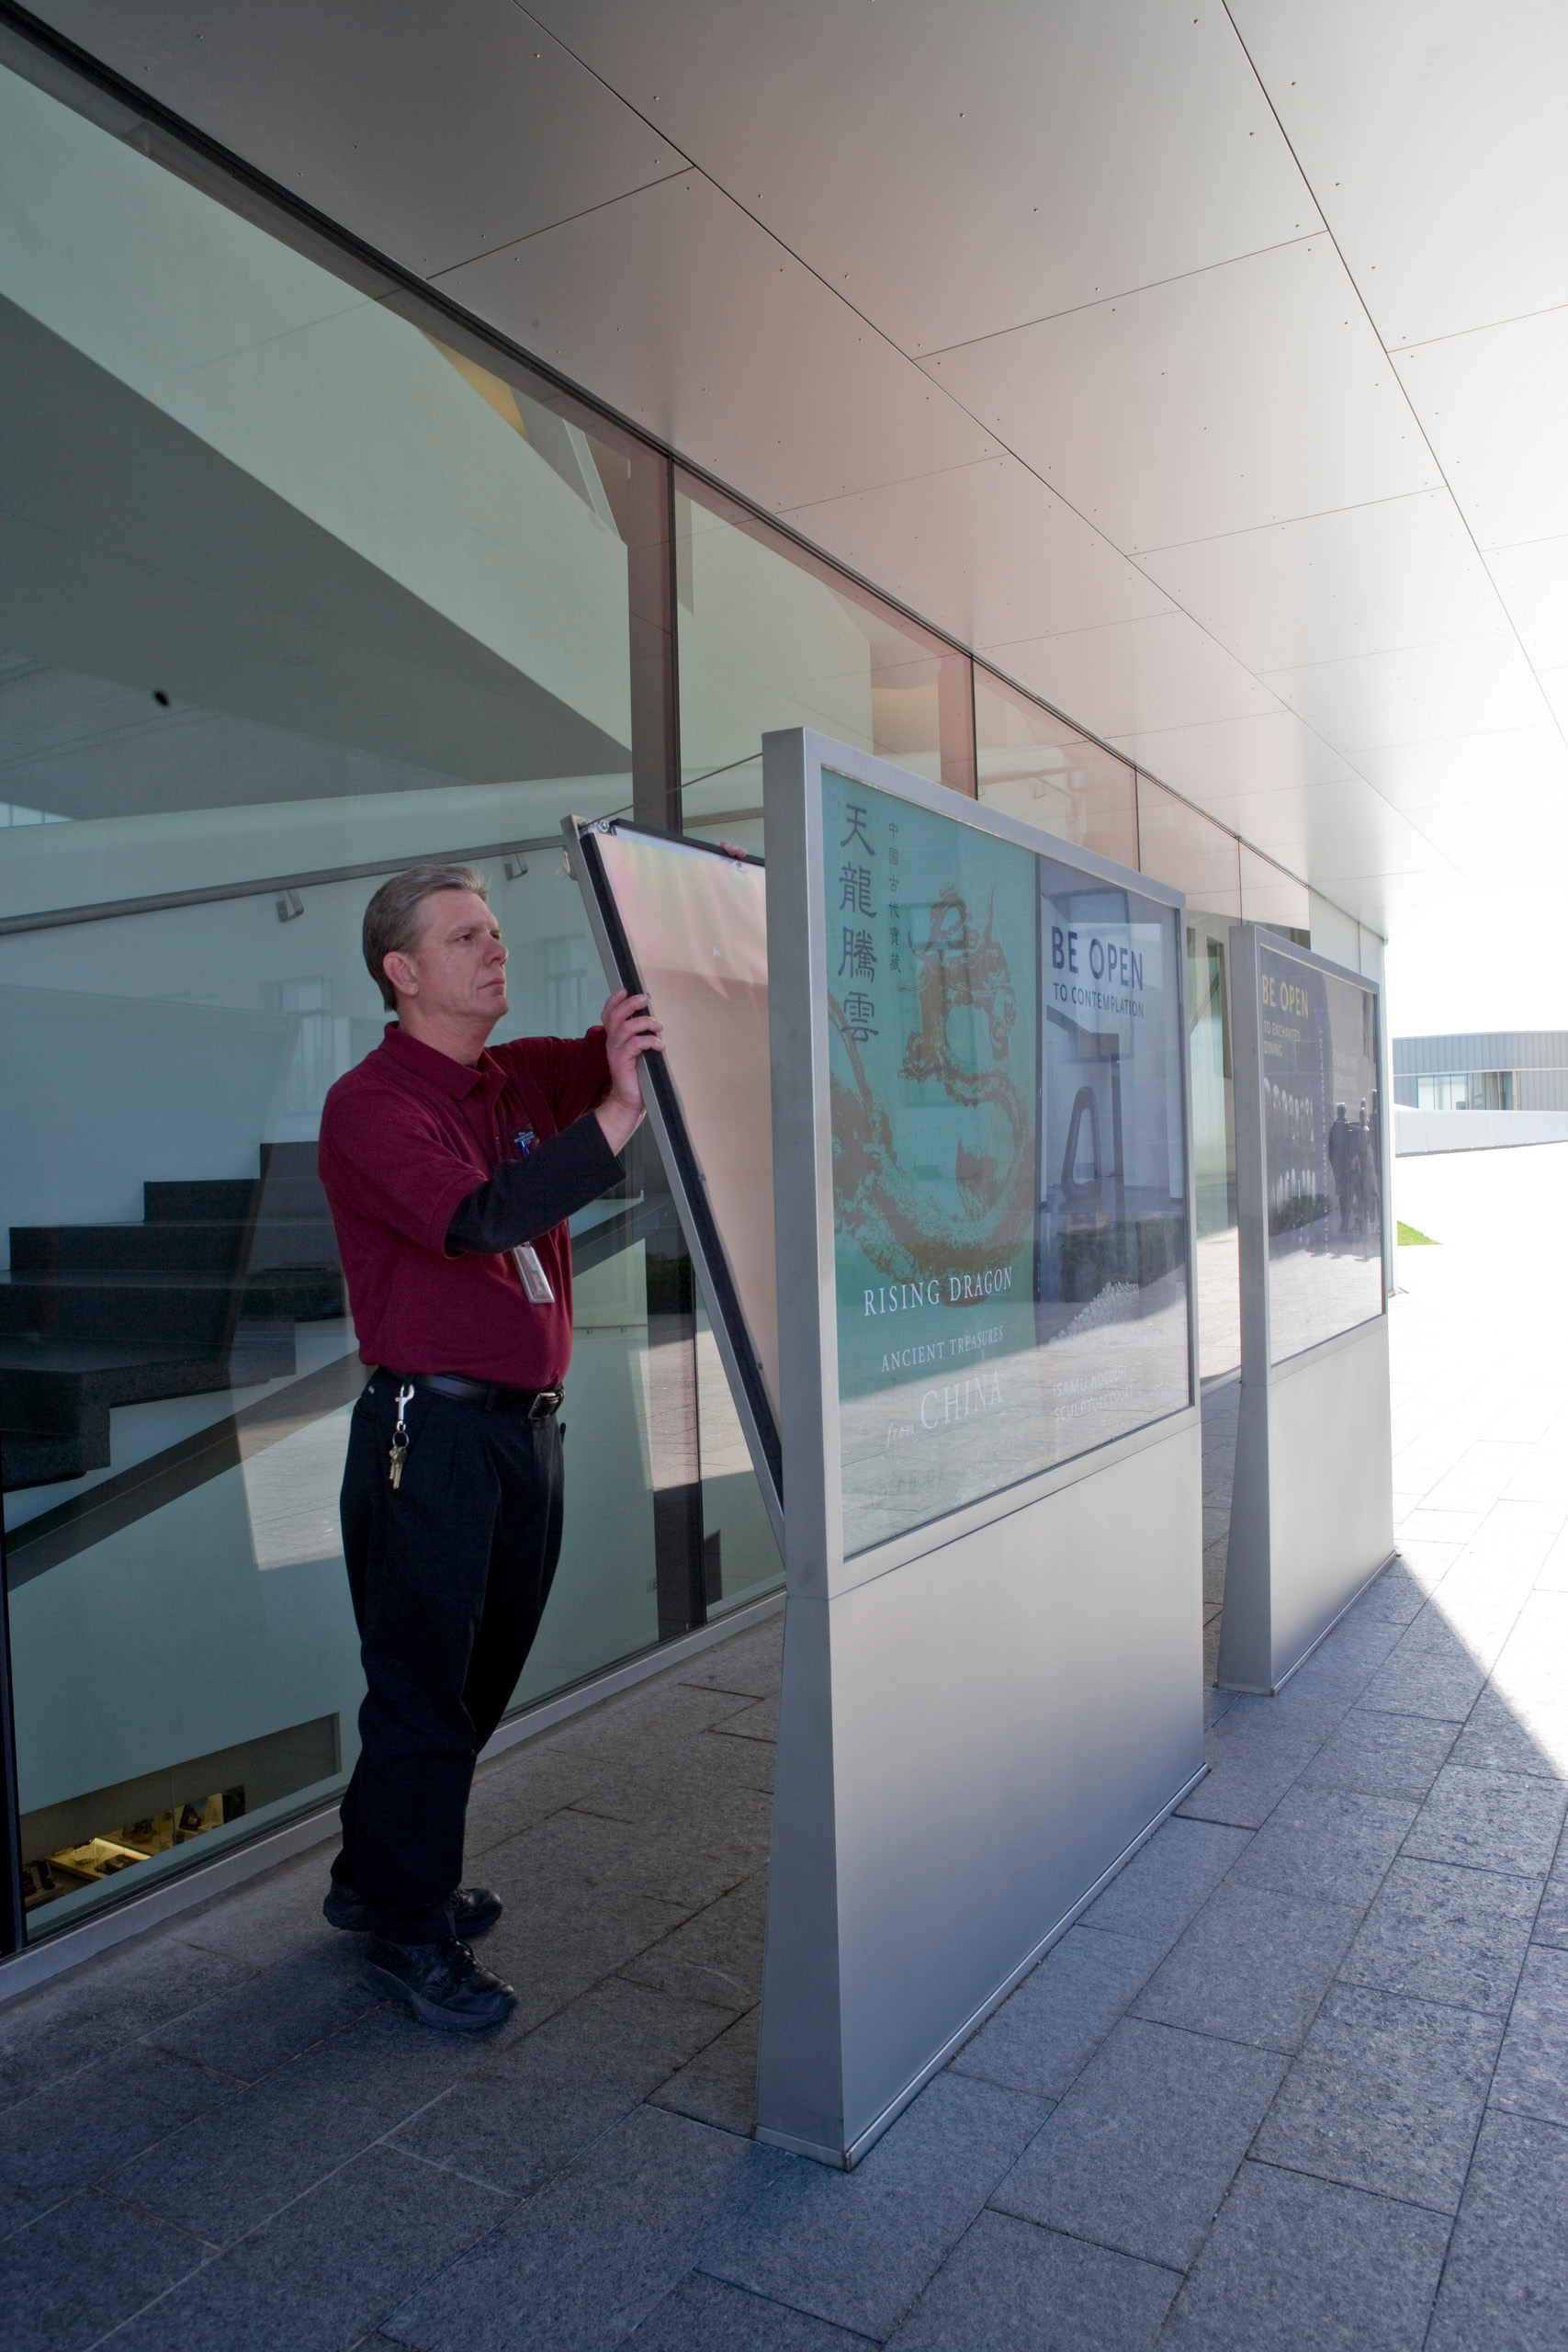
[976,665,1138,865]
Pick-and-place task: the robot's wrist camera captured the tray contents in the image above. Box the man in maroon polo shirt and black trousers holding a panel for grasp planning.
[320,865,663,2032]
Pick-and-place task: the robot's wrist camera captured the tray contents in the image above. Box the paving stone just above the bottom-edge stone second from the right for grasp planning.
[1253,1985,1502,2213]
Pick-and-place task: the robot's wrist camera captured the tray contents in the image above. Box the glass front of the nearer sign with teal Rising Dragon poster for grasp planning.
[823,774,1190,1553]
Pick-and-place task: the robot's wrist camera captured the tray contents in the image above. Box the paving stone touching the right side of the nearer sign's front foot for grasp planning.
[701,2072,1046,2338]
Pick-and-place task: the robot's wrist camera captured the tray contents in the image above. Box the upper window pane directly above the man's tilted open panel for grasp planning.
[674,475,976,849]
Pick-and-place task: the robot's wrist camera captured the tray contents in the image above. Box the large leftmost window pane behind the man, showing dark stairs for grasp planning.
[0,75,696,1931]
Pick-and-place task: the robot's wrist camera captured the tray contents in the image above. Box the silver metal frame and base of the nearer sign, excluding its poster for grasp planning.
[757,729,1203,2166]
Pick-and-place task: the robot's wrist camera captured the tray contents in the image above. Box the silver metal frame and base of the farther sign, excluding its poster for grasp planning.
[1220,924,1394,1691]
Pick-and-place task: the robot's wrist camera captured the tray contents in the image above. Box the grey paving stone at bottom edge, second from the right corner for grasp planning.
[1159,2164,1479,2352]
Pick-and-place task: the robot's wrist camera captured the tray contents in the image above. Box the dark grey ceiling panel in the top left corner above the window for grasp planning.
[38,0,686,277]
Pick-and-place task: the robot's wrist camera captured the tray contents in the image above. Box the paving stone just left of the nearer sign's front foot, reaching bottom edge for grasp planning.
[383,2108,771,2352]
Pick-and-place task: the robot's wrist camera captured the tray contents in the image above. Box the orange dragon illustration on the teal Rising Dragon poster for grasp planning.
[828,889,1034,1282]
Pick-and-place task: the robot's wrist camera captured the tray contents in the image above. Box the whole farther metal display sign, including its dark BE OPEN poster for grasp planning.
[1220,924,1394,1691]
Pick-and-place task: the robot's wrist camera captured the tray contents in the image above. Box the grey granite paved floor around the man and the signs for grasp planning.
[0,1148,1568,2352]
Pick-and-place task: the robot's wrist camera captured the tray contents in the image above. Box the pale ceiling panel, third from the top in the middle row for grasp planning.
[1143,489,1506,671]
